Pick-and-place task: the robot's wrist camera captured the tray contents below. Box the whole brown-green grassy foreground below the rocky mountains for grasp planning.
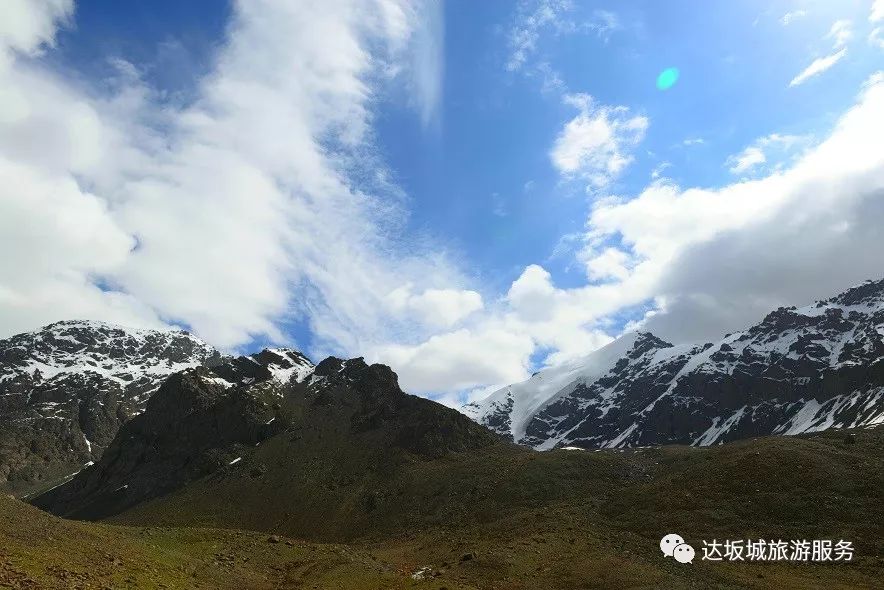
[6,429,884,590]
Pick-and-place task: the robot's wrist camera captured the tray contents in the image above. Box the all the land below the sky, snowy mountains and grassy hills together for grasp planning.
[0,283,884,590]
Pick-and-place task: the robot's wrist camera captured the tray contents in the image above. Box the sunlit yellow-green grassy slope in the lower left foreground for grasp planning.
[0,496,459,590]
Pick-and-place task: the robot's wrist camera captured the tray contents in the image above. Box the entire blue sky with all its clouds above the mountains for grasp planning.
[0,0,884,404]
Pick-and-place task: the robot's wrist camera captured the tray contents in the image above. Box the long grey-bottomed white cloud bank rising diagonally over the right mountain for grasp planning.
[418,73,884,403]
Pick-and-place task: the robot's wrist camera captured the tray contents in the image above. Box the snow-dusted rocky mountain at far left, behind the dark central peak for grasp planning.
[0,321,313,487]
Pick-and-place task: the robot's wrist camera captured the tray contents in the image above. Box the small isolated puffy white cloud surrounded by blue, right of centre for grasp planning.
[550,94,648,187]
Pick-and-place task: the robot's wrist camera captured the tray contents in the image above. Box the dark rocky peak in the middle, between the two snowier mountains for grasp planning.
[33,351,499,518]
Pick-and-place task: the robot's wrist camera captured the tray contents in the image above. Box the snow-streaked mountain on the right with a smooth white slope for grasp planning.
[463,280,884,449]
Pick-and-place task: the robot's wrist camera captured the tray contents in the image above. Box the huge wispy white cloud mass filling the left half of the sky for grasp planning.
[0,0,460,353]
